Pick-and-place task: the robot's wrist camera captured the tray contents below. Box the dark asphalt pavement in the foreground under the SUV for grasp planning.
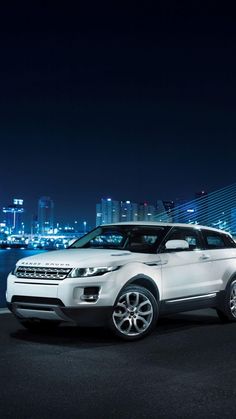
[0,310,236,419]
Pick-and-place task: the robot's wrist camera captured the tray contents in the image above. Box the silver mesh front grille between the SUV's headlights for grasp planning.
[15,266,71,281]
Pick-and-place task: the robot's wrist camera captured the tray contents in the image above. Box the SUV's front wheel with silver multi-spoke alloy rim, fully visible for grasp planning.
[110,285,159,341]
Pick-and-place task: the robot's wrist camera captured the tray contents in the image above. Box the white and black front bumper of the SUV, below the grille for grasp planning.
[6,272,120,327]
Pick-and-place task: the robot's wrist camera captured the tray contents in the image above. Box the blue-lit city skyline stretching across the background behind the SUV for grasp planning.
[0,183,236,235]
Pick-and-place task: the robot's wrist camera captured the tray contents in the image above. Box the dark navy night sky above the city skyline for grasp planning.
[0,1,236,225]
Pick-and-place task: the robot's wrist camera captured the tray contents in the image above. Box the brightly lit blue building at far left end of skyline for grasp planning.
[2,198,25,234]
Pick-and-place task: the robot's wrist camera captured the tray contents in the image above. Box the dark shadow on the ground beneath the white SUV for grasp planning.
[10,310,222,349]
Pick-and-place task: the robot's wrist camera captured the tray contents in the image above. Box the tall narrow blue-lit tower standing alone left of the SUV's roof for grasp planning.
[38,196,54,234]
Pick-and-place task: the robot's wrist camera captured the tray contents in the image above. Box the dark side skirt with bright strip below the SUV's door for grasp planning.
[160,291,224,315]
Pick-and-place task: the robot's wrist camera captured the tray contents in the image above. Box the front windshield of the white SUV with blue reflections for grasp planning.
[69,225,167,253]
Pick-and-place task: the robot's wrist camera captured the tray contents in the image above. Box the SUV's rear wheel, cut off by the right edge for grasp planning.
[216,278,236,323]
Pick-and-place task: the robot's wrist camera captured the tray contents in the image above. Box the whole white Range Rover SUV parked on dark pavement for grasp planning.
[7,222,236,340]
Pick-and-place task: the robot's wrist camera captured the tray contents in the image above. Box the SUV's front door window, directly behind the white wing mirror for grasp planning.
[163,227,202,250]
